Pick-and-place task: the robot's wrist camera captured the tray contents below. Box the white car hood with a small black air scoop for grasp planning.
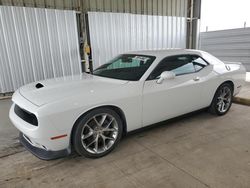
[19,73,128,106]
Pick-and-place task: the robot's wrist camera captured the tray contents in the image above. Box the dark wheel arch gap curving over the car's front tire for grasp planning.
[70,105,127,148]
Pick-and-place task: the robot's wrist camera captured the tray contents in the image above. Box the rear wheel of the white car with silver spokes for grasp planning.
[209,83,233,115]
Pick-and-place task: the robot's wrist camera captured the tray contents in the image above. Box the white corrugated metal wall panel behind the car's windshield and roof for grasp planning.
[88,12,186,68]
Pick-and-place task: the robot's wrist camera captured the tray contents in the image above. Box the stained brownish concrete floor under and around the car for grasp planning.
[0,100,250,188]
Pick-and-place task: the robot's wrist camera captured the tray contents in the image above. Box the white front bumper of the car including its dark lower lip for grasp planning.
[9,91,71,160]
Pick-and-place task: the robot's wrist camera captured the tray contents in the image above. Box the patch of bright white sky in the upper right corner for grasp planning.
[201,0,250,32]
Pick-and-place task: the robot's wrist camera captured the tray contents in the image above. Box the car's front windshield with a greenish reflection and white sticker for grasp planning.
[93,54,155,81]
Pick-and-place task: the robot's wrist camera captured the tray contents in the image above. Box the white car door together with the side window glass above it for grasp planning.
[142,55,210,126]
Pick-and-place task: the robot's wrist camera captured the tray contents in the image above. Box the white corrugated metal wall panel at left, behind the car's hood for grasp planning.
[0,6,81,93]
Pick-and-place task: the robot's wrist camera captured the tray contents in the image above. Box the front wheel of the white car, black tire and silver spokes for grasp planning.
[72,108,123,158]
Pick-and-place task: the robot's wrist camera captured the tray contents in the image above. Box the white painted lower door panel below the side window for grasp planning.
[143,73,203,126]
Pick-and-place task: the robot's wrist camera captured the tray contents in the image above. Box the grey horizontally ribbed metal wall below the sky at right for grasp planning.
[200,28,250,71]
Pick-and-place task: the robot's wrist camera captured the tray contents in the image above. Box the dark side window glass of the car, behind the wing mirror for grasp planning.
[148,55,208,80]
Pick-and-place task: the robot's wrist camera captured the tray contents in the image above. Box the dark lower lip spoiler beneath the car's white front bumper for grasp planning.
[19,132,71,160]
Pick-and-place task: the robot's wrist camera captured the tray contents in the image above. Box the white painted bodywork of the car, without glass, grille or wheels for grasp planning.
[10,50,245,151]
